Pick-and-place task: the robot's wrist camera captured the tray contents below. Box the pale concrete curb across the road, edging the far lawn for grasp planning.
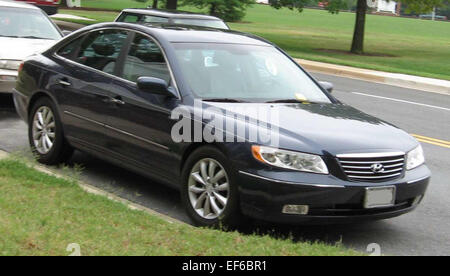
[295,59,450,95]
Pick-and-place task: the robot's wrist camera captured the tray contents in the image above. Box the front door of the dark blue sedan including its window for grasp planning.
[107,34,179,179]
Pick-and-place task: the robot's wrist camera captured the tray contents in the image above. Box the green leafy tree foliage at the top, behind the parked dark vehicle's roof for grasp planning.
[182,0,255,21]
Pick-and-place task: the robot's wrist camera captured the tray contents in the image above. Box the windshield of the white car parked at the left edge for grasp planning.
[0,7,61,40]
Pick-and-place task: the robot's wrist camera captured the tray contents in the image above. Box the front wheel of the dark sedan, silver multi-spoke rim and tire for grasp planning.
[181,146,241,228]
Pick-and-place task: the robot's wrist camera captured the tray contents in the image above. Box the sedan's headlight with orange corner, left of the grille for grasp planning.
[252,146,328,174]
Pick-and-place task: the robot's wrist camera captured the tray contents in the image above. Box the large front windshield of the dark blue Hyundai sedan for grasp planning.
[173,43,331,103]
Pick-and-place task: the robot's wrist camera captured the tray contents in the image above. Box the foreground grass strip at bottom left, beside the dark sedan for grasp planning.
[0,159,362,256]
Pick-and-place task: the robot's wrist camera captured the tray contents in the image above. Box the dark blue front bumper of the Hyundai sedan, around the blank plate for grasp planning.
[238,165,430,224]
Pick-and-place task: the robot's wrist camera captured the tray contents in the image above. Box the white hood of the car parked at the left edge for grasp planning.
[0,37,56,60]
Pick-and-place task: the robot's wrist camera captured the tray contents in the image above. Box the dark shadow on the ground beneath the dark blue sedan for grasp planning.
[68,151,401,251]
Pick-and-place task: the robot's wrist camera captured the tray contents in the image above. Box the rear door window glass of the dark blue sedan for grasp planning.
[76,30,128,74]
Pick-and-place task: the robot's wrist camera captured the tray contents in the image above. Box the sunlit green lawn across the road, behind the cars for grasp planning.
[56,0,450,80]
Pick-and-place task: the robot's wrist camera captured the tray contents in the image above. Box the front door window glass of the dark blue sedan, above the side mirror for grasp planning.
[123,34,170,83]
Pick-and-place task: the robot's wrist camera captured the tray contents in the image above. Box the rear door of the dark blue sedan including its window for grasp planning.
[54,30,128,150]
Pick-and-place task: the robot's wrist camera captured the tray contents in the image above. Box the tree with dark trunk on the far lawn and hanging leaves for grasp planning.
[269,0,443,54]
